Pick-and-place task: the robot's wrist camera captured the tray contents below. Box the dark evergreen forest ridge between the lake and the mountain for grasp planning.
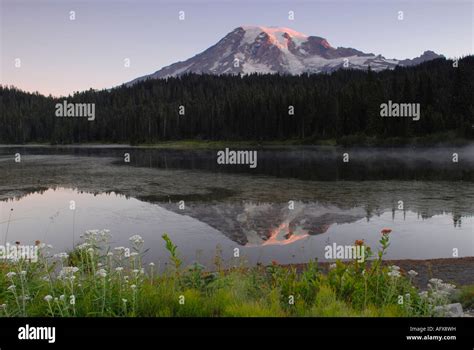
[0,56,474,144]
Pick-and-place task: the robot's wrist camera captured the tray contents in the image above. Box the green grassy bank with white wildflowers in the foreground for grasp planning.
[0,230,471,317]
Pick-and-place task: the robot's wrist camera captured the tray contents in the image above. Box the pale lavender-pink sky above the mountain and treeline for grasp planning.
[0,0,474,96]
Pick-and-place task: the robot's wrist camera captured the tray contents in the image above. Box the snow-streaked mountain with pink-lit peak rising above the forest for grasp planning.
[128,26,443,84]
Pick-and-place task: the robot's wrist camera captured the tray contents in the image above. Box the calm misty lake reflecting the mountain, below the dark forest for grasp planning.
[0,145,474,268]
